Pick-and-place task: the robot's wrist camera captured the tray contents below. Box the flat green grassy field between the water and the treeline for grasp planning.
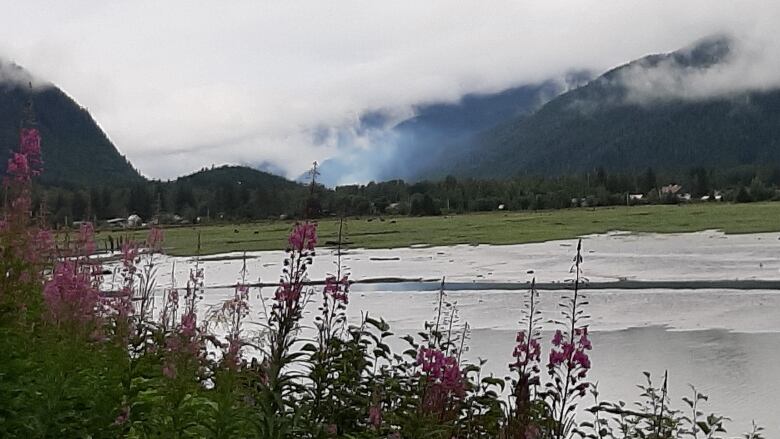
[97,202,780,256]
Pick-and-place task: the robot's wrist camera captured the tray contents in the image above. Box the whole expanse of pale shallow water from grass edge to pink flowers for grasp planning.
[120,231,780,438]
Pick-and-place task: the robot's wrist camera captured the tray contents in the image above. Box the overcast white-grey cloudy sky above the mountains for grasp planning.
[0,0,780,179]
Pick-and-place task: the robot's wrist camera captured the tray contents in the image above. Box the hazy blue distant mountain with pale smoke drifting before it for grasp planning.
[312,72,590,186]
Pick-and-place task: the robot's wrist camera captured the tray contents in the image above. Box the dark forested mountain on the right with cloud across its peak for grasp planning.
[443,37,780,178]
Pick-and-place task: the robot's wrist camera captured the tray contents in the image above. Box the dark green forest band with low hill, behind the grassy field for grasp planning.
[35,166,780,226]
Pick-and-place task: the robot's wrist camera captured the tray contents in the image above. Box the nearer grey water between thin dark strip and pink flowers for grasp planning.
[342,290,780,437]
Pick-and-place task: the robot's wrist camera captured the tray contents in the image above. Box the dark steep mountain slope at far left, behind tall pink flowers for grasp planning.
[0,61,143,185]
